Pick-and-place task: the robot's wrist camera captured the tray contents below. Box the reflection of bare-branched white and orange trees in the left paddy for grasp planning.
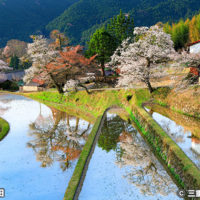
[27,108,90,171]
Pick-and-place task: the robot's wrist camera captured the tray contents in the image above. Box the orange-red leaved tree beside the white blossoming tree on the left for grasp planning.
[47,45,97,93]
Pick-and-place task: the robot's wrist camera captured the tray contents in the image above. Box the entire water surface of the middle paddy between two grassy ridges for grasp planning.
[79,113,179,200]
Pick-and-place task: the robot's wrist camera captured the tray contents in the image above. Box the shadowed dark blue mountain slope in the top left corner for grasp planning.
[0,0,76,47]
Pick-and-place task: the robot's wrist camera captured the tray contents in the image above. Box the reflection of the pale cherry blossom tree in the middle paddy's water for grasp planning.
[117,133,176,195]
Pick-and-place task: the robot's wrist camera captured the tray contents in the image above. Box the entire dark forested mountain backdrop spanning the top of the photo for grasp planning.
[0,0,200,47]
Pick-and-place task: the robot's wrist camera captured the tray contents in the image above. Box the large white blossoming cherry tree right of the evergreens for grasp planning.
[111,26,176,92]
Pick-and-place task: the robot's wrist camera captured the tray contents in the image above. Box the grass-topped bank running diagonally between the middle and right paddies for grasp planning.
[127,90,200,189]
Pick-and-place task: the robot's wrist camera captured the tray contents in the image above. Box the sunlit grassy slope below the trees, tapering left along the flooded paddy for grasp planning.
[24,90,129,119]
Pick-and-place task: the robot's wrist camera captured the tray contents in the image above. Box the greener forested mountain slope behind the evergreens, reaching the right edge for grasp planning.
[47,0,200,43]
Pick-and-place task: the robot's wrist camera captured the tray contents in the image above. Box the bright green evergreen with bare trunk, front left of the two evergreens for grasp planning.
[86,27,117,77]
